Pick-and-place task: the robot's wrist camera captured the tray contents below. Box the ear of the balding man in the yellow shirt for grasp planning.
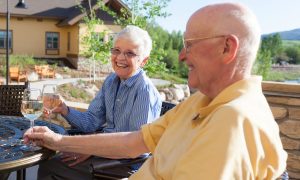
[223,34,239,64]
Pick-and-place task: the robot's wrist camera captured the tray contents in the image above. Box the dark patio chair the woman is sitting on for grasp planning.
[90,102,175,179]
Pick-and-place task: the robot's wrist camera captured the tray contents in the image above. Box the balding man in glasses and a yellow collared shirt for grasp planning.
[25,3,287,180]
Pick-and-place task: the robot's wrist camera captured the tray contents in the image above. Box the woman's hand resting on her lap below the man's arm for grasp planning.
[60,152,91,167]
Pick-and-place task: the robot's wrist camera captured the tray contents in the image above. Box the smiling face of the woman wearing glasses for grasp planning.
[111,37,148,80]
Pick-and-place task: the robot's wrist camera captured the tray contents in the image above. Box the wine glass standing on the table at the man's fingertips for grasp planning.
[21,88,43,151]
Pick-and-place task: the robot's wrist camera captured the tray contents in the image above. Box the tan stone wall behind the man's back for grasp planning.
[262,82,300,179]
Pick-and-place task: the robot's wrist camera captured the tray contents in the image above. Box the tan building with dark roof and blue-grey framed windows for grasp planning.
[0,0,125,67]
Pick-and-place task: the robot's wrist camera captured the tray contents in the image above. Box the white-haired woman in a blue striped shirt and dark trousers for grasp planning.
[38,26,162,180]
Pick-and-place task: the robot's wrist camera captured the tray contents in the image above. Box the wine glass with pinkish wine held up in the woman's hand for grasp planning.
[42,84,61,123]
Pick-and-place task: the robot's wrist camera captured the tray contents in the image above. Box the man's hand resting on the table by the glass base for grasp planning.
[23,126,62,150]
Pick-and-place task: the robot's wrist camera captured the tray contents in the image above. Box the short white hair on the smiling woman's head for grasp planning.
[113,25,152,58]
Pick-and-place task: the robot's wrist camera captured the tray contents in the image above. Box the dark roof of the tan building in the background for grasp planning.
[0,0,127,26]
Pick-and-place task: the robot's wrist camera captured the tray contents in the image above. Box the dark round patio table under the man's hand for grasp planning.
[0,116,66,179]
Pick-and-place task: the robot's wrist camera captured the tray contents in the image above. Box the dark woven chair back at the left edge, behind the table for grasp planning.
[0,82,28,117]
